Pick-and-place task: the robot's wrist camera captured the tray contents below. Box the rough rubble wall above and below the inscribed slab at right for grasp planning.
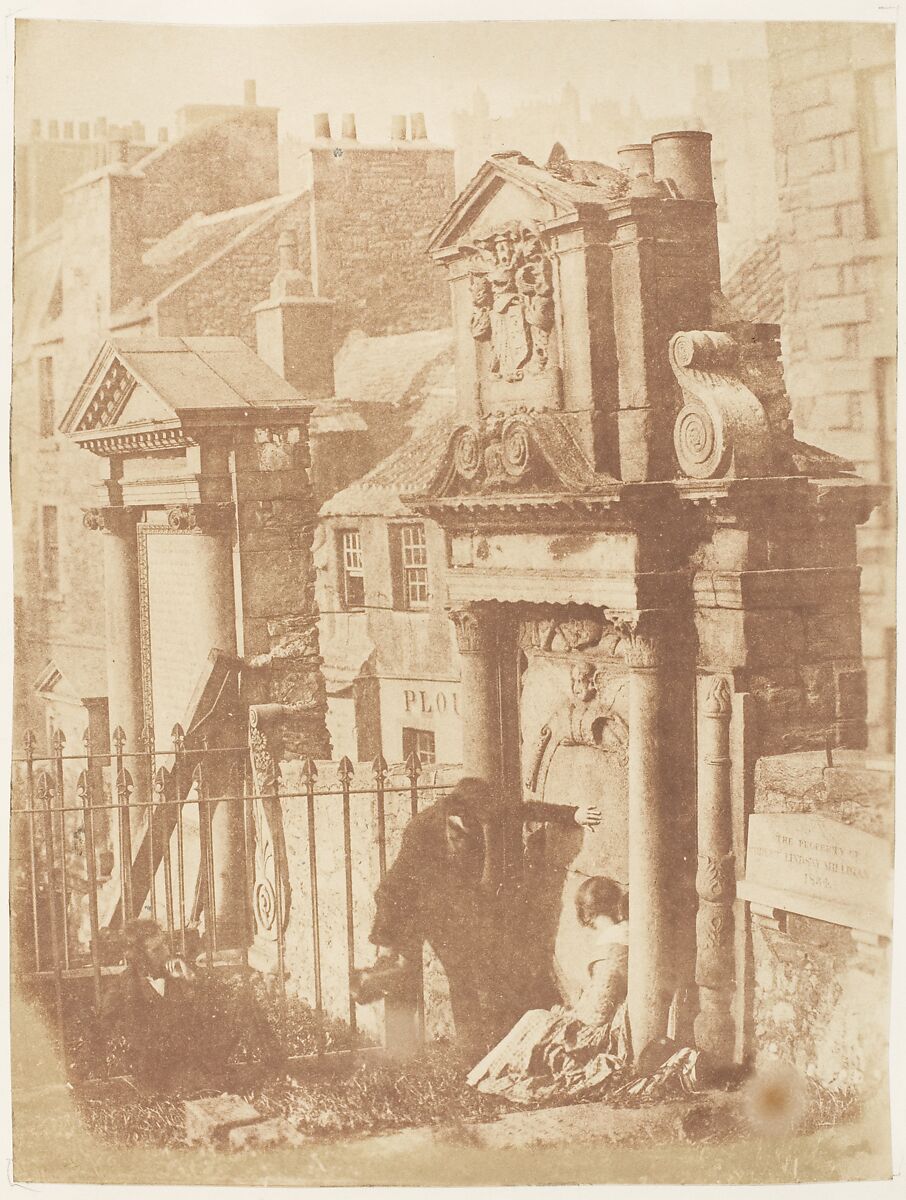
[751,751,893,1092]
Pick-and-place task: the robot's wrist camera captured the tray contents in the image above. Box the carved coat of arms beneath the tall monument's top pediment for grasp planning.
[461,222,554,383]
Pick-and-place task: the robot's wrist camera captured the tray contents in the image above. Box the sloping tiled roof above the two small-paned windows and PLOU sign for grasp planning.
[320,395,456,517]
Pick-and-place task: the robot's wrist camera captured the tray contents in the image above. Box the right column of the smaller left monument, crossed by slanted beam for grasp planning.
[167,504,247,949]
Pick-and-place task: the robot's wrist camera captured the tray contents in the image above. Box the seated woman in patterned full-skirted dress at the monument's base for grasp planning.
[468,875,629,1104]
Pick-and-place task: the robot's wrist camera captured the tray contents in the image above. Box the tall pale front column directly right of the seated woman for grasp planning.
[619,613,673,1056]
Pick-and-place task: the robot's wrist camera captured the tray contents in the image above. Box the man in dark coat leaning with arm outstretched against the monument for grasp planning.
[354,779,601,1051]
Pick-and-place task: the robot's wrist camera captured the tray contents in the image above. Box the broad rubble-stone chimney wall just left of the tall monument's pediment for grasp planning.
[310,139,454,342]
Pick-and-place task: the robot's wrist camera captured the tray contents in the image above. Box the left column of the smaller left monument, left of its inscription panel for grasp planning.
[84,506,144,758]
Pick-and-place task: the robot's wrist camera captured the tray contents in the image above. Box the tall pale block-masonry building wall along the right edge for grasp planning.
[767,22,896,751]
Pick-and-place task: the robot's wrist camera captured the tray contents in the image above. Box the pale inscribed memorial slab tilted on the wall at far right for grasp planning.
[737,812,893,936]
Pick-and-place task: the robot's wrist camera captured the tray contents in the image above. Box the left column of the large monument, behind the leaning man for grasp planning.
[450,605,504,884]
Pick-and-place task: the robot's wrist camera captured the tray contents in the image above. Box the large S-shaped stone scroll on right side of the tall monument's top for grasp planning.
[670,330,775,479]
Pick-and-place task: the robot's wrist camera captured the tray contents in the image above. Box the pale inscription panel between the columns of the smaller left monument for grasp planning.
[148,533,211,746]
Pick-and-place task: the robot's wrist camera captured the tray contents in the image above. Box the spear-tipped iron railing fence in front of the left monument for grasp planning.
[11,726,457,1084]
